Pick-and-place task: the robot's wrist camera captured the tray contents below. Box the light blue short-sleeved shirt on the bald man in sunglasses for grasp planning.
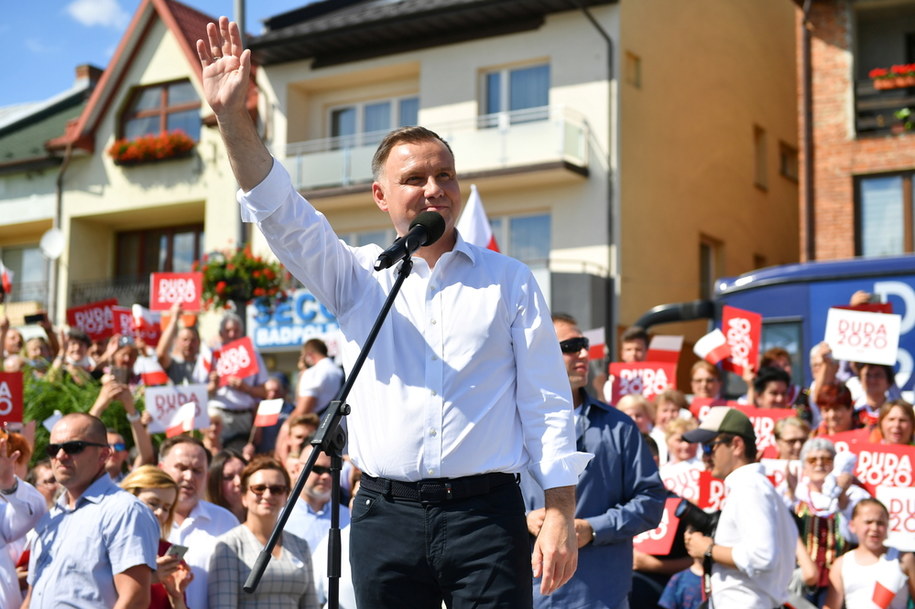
[29,472,160,609]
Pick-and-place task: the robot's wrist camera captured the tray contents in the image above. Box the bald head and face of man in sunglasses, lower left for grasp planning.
[50,417,111,495]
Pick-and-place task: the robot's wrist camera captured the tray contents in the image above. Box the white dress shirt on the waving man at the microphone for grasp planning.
[238,161,589,488]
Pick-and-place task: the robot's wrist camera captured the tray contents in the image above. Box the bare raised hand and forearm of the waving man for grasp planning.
[197,17,273,191]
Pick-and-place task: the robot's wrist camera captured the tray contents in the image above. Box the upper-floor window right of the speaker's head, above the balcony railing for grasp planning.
[480,64,550,127]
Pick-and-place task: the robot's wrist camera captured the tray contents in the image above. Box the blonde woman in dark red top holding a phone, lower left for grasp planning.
[121,465,193,609]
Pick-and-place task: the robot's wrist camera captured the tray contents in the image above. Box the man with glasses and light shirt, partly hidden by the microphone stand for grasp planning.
[286,444,350,548]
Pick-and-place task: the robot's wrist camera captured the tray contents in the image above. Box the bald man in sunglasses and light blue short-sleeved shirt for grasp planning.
[23,413,159,609]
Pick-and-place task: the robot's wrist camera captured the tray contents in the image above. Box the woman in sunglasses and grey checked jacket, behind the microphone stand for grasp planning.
[207,455,320,609]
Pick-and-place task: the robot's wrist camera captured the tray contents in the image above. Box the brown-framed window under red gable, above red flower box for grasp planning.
[121,80,200,142]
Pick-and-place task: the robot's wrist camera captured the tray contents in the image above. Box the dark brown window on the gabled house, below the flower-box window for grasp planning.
[115,224,203,280]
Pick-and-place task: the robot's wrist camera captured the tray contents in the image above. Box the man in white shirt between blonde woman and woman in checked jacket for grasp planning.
[159,435,238,609]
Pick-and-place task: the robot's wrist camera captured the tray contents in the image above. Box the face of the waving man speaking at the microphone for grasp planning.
[372,140,462,237]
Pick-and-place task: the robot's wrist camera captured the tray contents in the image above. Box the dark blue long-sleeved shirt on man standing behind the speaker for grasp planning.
[521,392,667,609]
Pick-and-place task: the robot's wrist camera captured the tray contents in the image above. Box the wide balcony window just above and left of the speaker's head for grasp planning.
[330,97,419,148]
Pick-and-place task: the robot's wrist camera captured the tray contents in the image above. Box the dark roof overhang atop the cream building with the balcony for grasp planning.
[249,0,616,67]
